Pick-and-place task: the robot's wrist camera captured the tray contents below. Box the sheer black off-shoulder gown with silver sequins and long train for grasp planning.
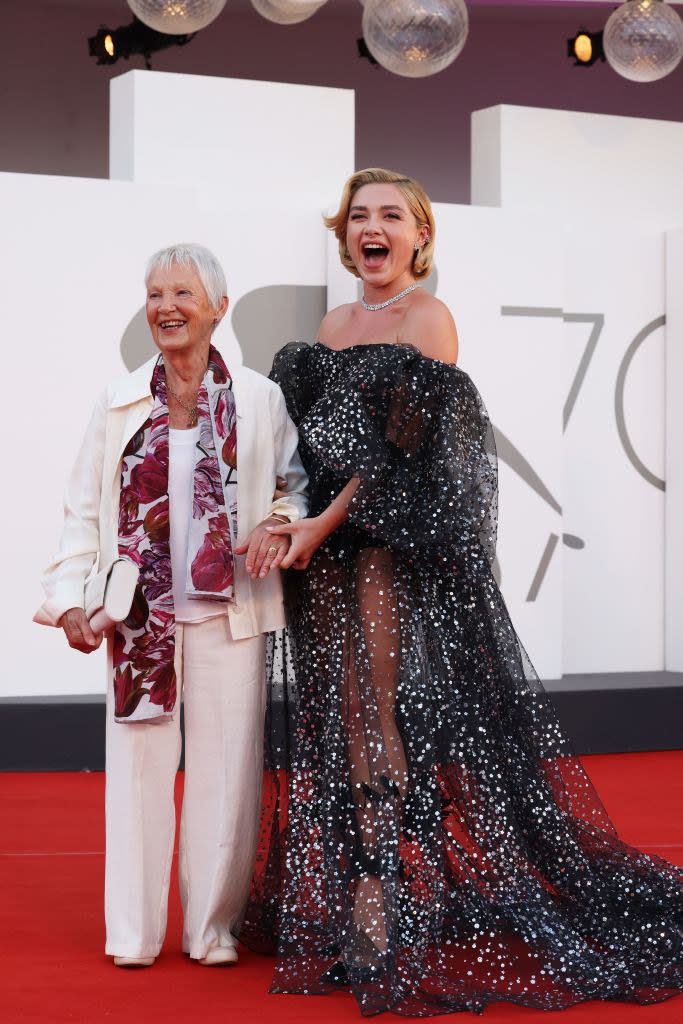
[241,343,683,1016]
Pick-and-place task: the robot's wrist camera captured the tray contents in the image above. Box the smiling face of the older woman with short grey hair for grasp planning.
[146,263,224,353]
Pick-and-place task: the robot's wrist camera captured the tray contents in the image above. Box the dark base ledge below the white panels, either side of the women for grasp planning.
[0,673,683,771]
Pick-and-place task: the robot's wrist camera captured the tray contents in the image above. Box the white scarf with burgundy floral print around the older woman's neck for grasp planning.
[114,346,237,722]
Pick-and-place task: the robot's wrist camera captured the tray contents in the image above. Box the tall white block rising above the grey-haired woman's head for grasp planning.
[110,71,354,213]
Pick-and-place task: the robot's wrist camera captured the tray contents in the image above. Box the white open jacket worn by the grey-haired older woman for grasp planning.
[35,355,308,640]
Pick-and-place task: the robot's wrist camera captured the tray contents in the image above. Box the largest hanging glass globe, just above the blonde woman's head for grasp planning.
[362,0,469,78]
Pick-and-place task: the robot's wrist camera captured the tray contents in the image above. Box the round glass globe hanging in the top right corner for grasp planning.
[602,0,683,82]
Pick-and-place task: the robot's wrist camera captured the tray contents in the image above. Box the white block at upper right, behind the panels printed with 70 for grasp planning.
[472,100,683,230]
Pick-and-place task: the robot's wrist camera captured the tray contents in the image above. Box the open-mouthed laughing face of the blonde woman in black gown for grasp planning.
[346,183,428,288]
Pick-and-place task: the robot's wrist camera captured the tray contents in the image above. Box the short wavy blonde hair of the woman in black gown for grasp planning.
[325,167,436,278]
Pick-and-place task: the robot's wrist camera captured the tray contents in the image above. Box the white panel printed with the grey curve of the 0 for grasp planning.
[563,231,665,673]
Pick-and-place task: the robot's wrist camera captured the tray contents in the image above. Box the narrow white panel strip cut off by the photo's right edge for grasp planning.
[665,230,683,672]
